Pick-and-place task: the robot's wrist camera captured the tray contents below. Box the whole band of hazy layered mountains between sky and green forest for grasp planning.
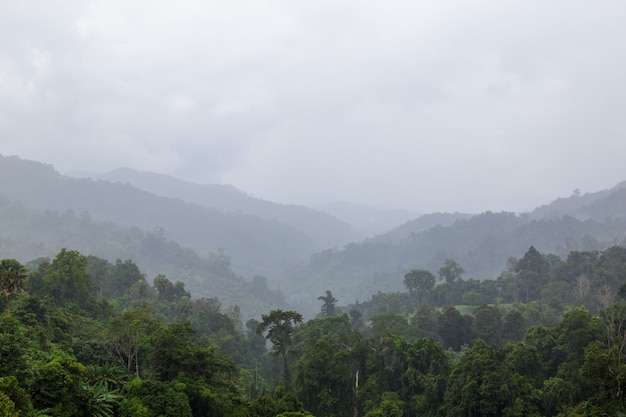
[0,156,626,317]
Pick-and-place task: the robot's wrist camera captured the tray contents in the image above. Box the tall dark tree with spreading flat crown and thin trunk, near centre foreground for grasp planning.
[257,309,302,387]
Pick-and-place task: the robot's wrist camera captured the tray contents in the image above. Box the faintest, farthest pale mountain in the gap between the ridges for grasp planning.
[319,201,419,237]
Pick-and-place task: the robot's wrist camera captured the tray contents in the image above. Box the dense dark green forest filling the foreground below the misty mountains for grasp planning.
[0,246,626,417]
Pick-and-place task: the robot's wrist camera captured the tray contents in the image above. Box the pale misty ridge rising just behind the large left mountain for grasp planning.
[92,168,362,249]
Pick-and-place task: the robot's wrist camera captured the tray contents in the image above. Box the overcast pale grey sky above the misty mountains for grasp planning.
[0,0,626,213]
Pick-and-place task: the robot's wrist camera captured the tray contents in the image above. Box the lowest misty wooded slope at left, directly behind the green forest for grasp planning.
[0,197,289,319]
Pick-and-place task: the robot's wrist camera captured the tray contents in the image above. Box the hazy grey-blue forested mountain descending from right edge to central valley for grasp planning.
[284,183,626,316]
